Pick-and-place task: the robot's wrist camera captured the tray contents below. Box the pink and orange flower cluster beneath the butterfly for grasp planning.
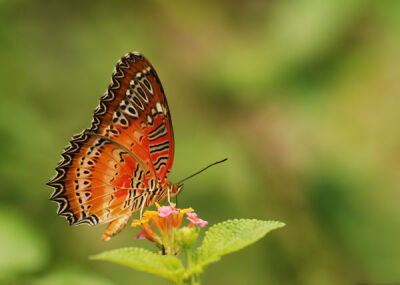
[132,203,208,255]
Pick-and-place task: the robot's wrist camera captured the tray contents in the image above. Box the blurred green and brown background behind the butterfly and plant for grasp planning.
[0,0,400,285]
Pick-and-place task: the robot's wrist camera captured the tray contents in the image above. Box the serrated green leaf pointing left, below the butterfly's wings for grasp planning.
[90,247,184,282]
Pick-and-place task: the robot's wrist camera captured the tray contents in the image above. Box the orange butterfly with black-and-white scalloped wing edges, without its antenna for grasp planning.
[48,52,174,240]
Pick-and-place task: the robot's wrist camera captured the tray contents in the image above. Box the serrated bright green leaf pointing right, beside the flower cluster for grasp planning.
[196,219,285,270]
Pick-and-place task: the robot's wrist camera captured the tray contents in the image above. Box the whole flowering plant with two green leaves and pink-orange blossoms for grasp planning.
[90,204,285,284]
